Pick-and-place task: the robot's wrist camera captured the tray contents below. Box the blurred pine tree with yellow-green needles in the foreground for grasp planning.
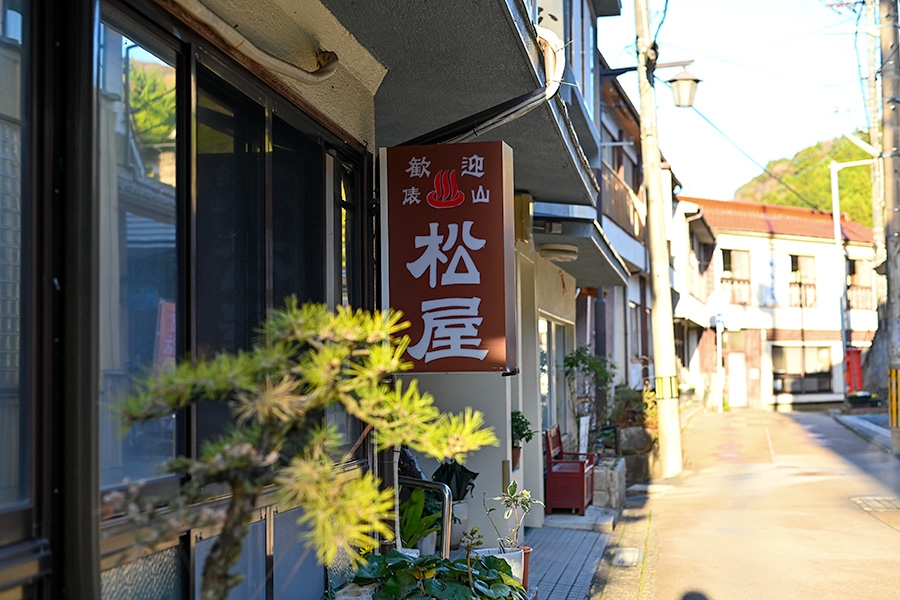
[104,298,497,600]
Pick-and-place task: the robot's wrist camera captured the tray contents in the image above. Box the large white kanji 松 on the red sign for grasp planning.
[406,221,485,288]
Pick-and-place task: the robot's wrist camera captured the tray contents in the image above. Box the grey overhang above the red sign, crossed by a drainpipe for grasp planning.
[323,0,599,205]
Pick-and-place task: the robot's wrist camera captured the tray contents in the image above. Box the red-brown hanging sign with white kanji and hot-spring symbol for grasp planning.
[381,142,516,372]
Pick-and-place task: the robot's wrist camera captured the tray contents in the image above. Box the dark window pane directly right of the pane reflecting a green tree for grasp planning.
[194,67,265,442]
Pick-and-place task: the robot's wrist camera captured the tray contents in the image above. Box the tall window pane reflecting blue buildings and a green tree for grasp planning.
[96,25,178,487]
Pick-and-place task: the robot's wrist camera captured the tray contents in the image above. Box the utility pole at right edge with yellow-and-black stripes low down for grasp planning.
[880,0,900,454]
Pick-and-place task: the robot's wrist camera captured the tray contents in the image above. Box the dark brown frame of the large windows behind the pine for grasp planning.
[97,0,379,568]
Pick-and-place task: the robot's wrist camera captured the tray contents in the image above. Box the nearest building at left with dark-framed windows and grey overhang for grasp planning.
[0,0,640,599]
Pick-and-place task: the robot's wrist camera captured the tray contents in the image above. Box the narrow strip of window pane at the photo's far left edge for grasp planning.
[0,0,29,511]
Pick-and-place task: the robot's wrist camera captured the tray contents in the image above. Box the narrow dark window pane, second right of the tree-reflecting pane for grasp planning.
[272,118,326,306]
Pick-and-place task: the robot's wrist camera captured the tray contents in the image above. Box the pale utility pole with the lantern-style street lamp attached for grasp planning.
[634,0,682,478]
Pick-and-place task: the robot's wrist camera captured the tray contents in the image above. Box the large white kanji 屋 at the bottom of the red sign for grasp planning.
[407,298,488,363]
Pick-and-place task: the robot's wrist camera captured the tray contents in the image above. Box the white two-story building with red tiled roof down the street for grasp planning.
[679,197,878,410]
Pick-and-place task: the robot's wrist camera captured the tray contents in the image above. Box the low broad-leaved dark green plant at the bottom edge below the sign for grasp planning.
[353,550,526,600]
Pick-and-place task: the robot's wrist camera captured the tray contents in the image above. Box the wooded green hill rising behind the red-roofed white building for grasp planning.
[734,135,872,227]
